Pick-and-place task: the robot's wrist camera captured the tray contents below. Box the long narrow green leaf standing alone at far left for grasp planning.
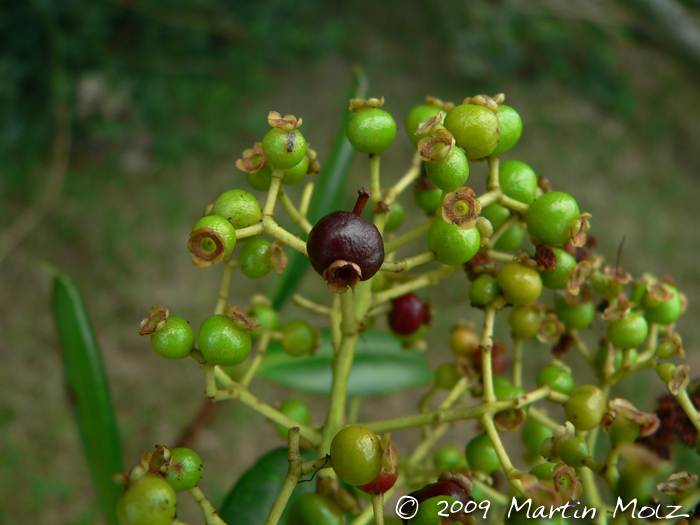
[53,269,122,524]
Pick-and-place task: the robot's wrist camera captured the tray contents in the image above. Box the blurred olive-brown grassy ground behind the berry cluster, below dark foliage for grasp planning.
[0,7,700,525]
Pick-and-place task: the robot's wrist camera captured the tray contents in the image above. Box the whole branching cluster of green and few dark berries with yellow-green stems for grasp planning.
[117,87,700,525]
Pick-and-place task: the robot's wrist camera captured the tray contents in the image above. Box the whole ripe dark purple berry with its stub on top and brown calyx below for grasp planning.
[306,188,384,293]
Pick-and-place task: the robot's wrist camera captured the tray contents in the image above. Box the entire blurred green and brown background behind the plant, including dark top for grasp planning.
[0,0,700,525]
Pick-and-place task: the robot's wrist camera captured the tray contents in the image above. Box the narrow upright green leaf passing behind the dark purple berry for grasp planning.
[270,66,368,310]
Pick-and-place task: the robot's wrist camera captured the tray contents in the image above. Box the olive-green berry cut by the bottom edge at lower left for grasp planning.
[117,475,177,525]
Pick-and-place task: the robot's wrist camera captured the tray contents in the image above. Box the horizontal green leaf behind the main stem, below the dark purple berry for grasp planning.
[258,330,432,396]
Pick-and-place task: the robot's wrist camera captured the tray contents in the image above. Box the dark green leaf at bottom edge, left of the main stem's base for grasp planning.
[219,447,317,525]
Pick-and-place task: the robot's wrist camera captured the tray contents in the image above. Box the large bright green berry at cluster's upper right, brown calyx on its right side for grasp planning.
[525,191,581,246]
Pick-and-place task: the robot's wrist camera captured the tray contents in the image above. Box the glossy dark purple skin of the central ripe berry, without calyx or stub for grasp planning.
[306,211,384,281]
